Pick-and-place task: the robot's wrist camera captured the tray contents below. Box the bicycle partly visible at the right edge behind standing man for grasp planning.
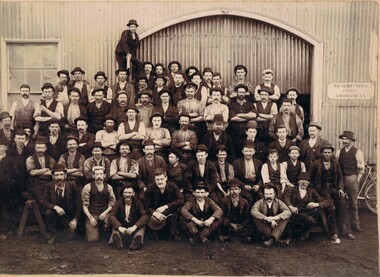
[358,164,377,214]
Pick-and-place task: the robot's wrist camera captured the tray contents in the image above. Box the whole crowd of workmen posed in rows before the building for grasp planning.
[0,20,365,250]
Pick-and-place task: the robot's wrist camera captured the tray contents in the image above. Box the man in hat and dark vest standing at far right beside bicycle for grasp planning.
[336,131,365,232]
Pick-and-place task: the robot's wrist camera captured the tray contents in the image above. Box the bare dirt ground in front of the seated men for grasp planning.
[0,210,378,277]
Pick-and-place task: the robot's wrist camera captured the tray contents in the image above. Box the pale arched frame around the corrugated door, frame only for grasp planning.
[140,9,323,122]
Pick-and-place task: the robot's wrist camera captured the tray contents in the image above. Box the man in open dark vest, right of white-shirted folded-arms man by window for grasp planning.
[63,88,87,134]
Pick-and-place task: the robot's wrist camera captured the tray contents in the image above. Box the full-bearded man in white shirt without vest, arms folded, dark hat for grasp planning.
[95,114,118,161]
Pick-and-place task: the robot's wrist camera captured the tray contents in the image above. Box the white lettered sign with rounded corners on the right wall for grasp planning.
[327,83,375,100]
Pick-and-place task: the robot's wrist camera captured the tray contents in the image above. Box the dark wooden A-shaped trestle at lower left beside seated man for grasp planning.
[17,192,47,237]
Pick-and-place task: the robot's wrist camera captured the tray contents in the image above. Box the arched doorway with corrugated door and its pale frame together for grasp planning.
[139,10,323,121]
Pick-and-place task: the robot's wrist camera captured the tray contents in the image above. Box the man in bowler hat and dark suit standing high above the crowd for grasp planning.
[115,19,143,76]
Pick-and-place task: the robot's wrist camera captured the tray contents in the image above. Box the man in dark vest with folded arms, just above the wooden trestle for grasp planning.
[26,137,55,204]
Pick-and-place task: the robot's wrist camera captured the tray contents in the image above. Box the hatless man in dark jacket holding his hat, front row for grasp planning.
[144,167,184,237]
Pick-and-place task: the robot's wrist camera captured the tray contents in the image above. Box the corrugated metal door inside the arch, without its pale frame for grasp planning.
[139,16,312,94]
